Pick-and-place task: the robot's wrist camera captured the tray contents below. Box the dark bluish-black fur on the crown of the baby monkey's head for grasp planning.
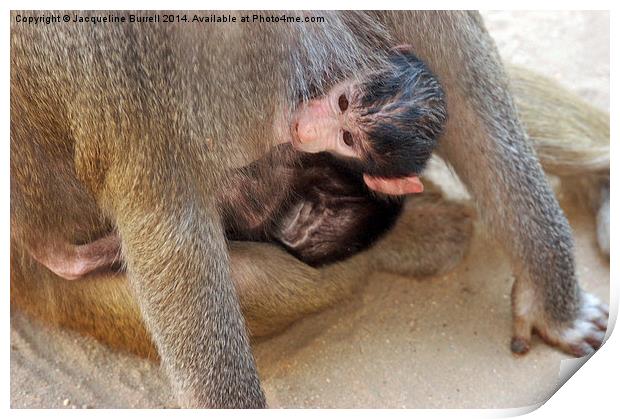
[334,47,447,178]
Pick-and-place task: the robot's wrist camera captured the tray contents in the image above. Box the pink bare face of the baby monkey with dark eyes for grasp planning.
[291,82,367,159]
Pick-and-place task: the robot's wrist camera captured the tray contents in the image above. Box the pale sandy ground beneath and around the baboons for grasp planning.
[11,12,609,408]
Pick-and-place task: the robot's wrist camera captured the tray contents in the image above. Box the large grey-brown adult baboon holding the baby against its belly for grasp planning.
[11,11,608,407]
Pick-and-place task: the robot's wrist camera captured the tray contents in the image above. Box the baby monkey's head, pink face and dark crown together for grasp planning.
[291,46,446,195]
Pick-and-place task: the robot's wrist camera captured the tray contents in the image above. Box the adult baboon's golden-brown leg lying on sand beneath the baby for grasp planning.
[11,188,471,357]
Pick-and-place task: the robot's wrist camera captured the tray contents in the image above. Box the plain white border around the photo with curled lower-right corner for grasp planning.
[0,0,620,418]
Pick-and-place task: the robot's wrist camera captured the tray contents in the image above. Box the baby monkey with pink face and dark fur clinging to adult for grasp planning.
[31,46,446,279]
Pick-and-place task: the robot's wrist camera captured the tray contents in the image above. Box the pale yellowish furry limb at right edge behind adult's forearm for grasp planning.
[507,65,609,257]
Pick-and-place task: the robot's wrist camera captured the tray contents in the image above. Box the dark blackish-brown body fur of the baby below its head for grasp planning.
[224,150,402,266]
